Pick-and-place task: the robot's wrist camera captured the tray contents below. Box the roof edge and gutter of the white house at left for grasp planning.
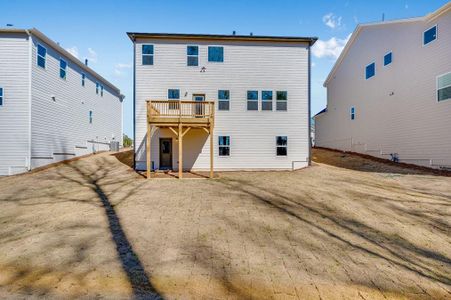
[0,28,124,98]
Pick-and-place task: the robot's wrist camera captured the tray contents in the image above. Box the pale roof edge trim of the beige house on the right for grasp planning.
[323,2,451,87]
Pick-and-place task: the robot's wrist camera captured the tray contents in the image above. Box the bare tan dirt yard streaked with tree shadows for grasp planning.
[0,150,451,299]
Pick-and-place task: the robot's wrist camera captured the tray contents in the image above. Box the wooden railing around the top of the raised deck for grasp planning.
[147,100,214,118]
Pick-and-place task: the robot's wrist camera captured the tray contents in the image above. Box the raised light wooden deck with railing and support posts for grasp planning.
[146,100,215,179]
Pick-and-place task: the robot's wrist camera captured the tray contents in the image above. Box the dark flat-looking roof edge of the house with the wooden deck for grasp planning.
[127,32,318,46]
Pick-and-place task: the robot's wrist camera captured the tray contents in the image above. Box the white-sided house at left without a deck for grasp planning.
[0,28,123,175]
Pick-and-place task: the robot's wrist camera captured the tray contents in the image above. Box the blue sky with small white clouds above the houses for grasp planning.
[0,0,448,136]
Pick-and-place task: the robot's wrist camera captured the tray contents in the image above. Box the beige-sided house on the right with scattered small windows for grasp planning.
[315,3,451,168]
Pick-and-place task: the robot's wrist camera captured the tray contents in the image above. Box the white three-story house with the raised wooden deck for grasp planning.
[128,33,316,176]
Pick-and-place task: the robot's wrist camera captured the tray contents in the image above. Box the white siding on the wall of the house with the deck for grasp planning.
[135,39,309,170]
